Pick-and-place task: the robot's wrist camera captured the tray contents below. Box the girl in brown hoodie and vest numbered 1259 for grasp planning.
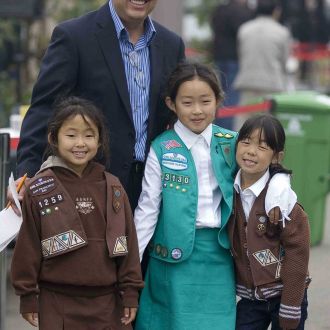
[11,97,143,330]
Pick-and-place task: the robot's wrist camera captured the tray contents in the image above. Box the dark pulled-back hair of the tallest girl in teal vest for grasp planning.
[166,60,224,102]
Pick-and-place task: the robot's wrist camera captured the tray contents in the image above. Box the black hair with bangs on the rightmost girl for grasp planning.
[236,114,292,176]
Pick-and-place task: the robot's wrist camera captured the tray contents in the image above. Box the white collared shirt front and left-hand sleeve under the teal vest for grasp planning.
[134,121,222,259]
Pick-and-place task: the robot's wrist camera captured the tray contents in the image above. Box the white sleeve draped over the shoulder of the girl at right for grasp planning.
[265,173,297,220]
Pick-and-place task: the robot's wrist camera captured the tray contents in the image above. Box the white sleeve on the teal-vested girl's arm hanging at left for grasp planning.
[134,148,162,260]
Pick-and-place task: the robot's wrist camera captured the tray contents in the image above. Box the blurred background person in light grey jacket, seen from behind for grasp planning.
[234,0,291,129]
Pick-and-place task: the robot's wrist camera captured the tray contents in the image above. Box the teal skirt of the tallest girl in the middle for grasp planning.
[135,228,236,330]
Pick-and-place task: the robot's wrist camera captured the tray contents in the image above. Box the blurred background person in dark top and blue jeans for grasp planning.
[211,0,253,129]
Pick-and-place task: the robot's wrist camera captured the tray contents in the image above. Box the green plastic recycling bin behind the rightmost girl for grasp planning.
[271,92,330,245]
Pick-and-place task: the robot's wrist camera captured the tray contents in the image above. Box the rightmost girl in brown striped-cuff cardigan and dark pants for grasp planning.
[229,115,310,330]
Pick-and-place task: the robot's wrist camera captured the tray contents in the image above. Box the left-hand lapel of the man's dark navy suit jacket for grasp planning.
[95,4,133,122]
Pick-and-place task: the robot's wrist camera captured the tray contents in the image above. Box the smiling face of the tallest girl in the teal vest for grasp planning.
[166,78,217,134]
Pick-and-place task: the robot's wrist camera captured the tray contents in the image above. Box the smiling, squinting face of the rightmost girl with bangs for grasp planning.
[236,128,279,188]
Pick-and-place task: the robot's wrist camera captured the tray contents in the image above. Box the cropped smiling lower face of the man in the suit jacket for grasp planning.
[112,0,157,26]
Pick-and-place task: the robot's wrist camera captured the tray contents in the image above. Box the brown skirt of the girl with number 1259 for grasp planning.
[39,288,132,330]
